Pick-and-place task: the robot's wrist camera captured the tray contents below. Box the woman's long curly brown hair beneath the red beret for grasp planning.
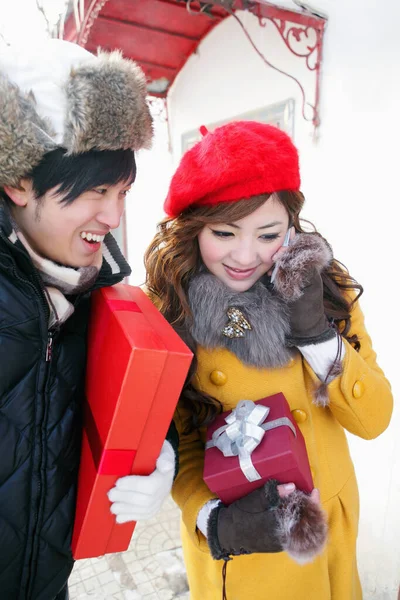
[144,191,363,433]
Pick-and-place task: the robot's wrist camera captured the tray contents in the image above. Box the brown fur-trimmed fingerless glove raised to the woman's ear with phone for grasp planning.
[274,233,336,346]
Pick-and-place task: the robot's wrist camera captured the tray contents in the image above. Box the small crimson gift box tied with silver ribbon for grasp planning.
[204,393,314,504]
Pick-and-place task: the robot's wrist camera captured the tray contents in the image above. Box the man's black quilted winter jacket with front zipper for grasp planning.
[0,206,129,600]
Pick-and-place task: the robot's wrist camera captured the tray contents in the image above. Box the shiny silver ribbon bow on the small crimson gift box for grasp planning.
[206,400,296,482]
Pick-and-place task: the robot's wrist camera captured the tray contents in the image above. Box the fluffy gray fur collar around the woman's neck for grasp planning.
[188,273,291,368]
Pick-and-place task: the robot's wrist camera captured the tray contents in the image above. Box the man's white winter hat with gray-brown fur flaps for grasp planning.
[0,40,153,188]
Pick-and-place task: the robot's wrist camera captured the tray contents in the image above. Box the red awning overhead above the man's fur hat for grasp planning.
[64,0,228,97]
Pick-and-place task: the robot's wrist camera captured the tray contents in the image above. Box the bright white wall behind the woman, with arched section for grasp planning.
[128,0,400,600]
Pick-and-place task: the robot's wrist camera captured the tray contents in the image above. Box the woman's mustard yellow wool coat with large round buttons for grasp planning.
[173,303,392,600]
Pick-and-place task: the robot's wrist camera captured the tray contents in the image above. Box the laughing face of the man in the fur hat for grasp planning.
[6,180,131,267]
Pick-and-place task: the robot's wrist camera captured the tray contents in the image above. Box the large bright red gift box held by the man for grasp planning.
[72,284,192,559]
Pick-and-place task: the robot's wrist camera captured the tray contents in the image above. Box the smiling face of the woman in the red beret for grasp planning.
[198,196,289,292]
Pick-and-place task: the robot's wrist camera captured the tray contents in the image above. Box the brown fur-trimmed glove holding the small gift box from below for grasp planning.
[207,480,327,563]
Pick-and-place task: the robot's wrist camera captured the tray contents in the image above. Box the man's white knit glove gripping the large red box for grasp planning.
[107,440,175,523]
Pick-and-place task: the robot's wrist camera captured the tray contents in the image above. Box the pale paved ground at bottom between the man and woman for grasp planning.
[69,498,189,600]
